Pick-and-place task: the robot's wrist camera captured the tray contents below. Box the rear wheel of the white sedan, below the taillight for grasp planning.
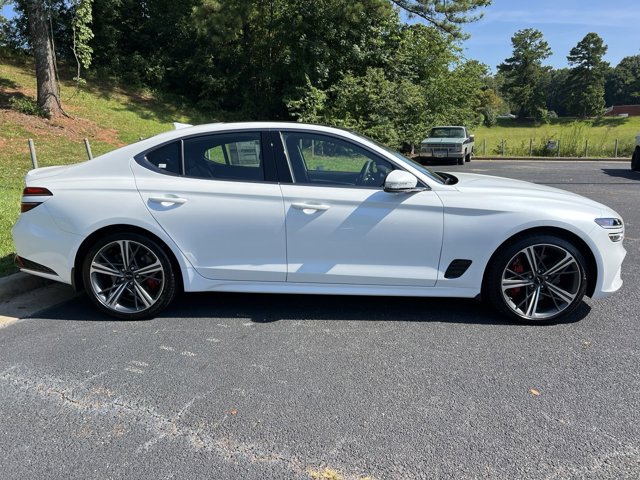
[82,232,177,320]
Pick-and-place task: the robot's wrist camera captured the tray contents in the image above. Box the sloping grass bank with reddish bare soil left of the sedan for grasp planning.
[0,60,207,276]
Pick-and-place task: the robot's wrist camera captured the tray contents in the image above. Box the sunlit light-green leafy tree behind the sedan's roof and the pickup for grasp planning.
[288,25,487,150]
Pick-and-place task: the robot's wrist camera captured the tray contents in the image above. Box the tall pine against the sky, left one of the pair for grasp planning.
[498,28,551,118]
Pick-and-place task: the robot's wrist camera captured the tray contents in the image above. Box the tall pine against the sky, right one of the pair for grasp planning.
[567,32,609,117]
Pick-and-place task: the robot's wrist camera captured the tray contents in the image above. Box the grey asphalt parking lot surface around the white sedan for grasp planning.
[0,161,640,479]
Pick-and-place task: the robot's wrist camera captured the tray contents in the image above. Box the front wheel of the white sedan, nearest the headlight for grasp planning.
[483,234,587,323]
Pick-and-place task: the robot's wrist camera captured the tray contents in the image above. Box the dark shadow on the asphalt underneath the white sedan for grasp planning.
[34,293,591,326]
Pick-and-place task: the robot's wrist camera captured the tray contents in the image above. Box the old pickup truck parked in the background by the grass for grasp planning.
[420,126,475,165]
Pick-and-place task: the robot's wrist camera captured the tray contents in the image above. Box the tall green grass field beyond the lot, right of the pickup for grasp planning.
[473,117,640,158]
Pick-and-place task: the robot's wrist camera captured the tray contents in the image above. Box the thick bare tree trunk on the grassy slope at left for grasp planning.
[25,0,64,117]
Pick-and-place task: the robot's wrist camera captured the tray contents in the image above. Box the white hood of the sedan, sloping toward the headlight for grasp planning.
[450,172,612,212]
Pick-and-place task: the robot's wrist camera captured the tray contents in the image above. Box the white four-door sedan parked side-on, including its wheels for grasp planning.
[13,122,626,322]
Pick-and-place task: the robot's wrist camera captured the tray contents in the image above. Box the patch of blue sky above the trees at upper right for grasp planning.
[462,0,640,72]
